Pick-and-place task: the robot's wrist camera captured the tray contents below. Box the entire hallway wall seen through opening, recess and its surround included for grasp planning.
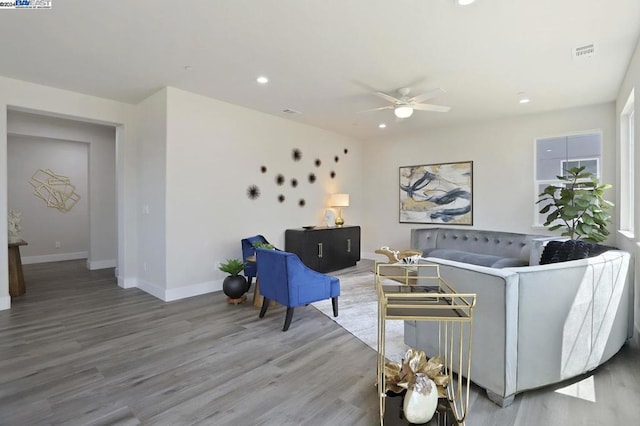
[7,111,118,269]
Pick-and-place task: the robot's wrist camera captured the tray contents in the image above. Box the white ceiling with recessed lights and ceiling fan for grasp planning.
[0,0,640,139]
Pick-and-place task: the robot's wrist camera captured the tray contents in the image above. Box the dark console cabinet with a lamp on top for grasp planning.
[284,226,360,272]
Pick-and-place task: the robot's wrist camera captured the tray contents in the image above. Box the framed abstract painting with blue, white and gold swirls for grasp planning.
[400,161,473,225]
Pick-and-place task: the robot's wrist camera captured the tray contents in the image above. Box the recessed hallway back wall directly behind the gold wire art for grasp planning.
[7,135,89,264]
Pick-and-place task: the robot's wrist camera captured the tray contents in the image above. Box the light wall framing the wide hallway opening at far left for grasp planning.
[0,76,138,310]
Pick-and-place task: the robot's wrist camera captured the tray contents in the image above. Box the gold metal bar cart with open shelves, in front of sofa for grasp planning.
[375,263,476,425]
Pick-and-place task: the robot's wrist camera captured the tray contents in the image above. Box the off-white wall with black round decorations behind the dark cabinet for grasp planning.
[160,88,364,299]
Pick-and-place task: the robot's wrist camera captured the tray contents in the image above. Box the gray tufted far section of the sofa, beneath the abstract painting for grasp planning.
[411,228,556,268]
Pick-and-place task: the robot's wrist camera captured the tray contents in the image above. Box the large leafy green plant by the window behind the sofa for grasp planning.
[536,167,613,243]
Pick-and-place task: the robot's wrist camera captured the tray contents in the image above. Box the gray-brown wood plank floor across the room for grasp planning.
[0,261,640,426]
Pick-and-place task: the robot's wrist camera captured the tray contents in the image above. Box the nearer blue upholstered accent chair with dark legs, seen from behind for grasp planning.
[256,248,340,331]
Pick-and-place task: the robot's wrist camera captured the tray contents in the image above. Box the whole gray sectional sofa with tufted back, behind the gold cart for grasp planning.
[405,228,633,407]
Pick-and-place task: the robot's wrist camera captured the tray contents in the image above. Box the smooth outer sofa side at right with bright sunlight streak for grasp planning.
[510,251,629,391]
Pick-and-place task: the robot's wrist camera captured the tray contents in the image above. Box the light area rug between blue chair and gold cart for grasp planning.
[313,271,406,361]
